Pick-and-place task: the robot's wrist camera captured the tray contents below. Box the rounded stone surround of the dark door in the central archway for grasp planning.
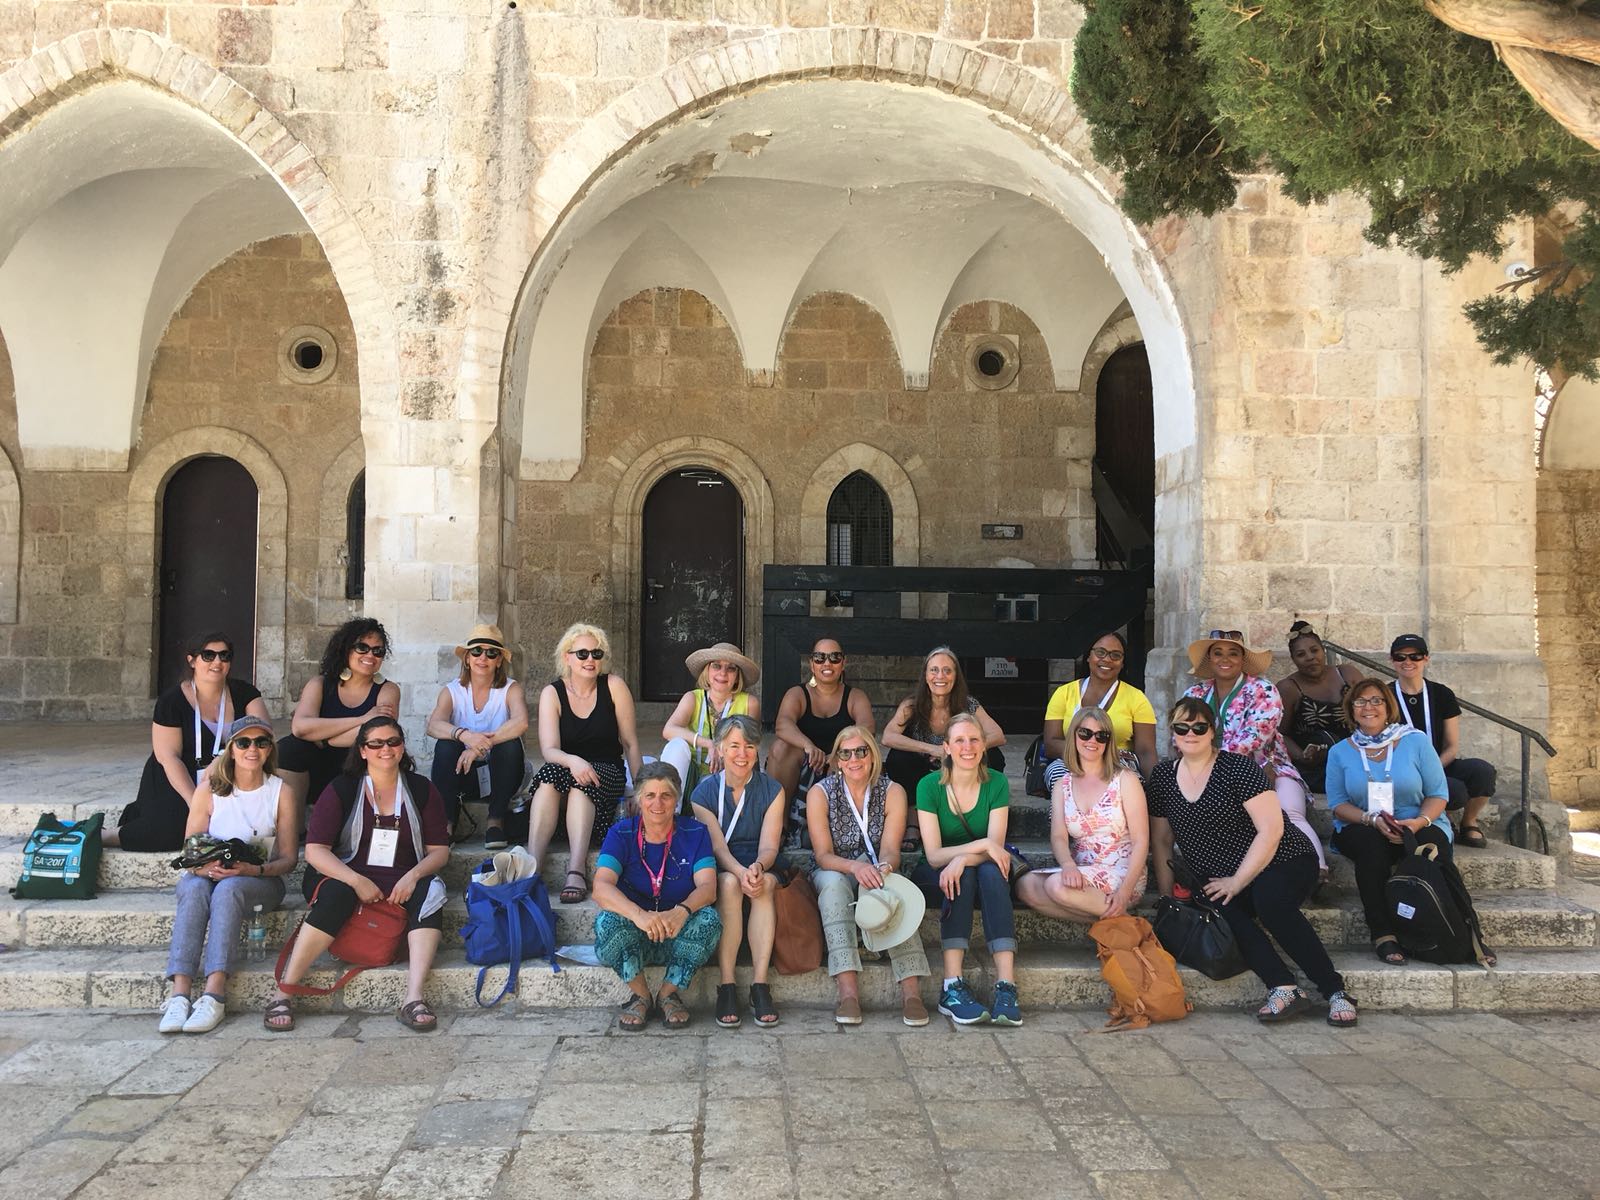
[606,434,774,685]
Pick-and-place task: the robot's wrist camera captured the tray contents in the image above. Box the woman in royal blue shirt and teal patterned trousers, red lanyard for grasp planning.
[594,763,722,1034]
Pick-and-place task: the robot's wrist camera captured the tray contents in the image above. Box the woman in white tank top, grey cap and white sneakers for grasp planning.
[158,714,299,1034]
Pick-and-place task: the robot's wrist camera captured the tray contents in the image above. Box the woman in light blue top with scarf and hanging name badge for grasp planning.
[1328,678,1451,966]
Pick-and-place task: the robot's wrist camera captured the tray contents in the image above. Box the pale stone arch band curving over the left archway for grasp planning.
[0,29,400,438]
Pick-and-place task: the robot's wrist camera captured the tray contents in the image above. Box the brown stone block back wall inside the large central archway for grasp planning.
[517,288,1094,670]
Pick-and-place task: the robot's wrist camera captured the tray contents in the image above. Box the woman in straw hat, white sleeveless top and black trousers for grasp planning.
[427,626,528,850]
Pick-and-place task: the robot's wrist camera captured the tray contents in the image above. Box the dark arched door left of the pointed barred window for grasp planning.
[638,467,744,699]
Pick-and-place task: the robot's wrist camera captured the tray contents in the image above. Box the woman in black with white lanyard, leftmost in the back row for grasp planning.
[101,634,267,851]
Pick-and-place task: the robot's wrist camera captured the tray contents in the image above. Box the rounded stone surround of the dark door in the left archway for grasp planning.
[122,426,290,704]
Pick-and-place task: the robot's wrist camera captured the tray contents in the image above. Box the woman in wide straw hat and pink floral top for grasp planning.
[1184,629,1328,877]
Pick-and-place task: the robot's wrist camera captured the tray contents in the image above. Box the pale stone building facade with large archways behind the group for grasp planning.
[0,0,1600,838]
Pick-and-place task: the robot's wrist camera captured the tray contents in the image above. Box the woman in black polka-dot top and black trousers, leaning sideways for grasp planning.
[1146,696,1357,1029]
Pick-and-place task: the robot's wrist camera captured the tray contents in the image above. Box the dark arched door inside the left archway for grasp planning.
[155,456,258,691]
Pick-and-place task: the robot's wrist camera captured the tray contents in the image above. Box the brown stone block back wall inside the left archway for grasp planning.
[0,235,362,718]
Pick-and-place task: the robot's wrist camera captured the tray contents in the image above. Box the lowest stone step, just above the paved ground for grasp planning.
[0,947,1600,1022]
